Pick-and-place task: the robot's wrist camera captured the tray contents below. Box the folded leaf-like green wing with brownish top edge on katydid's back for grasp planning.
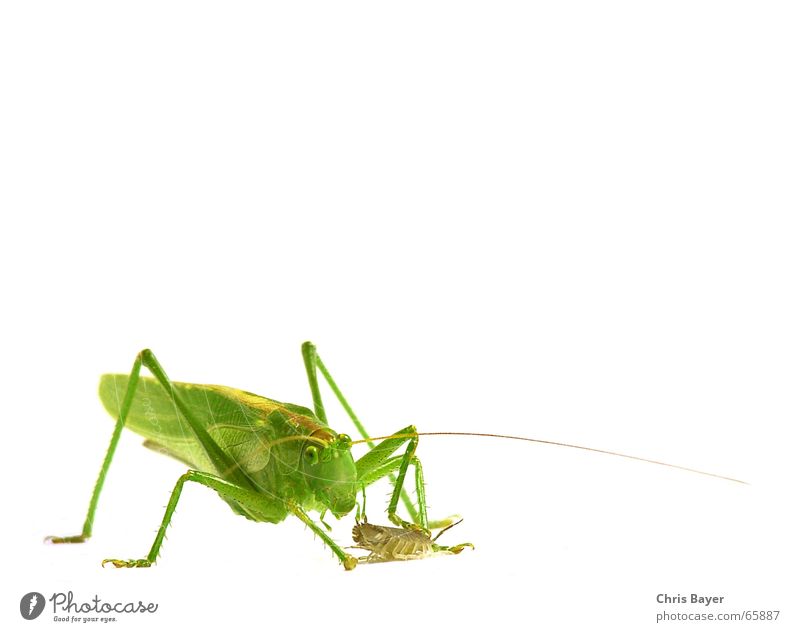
[100,374,319,477]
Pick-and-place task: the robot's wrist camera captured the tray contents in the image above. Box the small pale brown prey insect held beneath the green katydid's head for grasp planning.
[352,520,475,564]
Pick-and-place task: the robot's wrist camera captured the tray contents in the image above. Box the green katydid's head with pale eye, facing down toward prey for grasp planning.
[301,428,357,518]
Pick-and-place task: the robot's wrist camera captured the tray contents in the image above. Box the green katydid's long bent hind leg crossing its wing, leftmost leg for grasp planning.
[46,349,254,544]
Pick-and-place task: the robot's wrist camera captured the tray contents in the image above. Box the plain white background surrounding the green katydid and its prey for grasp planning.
[0,1,800,630]
